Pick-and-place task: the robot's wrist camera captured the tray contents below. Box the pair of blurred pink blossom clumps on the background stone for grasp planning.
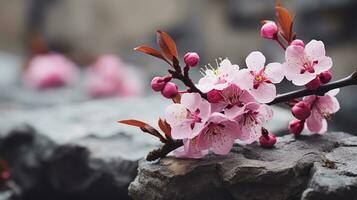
[24,53,142,98]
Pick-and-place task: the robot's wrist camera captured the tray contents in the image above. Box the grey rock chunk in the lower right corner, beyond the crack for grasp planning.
[302,137,357,200]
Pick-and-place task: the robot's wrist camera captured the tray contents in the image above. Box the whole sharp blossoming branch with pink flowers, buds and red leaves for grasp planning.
[119,1,357,160]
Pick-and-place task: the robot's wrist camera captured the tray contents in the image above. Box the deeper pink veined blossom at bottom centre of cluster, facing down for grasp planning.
[196,113,241,155]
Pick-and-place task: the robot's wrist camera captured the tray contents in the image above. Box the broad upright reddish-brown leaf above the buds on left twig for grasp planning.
[156,31,178,61]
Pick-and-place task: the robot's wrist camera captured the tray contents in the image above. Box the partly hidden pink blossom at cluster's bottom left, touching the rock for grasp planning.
[173,137,208,159]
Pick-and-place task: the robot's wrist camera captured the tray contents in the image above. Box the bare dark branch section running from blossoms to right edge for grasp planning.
[267,70,357,105]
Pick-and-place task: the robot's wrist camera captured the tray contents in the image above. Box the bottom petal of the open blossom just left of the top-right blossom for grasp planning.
[250,83,276,103]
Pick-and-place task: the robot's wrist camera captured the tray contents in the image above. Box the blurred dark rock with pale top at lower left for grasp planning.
[0,125,138,200]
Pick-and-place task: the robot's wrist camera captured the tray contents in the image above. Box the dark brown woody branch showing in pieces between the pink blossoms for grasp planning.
[146,70,357,161]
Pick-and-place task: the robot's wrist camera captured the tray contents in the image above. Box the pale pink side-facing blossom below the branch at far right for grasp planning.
[303,89,340,134]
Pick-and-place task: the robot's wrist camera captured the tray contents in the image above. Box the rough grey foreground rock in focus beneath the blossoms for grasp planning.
[129,132,357,200]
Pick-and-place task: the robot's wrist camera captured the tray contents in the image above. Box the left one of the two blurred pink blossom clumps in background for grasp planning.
[24,53,76,89]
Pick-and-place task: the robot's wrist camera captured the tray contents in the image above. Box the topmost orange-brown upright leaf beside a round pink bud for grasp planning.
[275,5,293,43]
